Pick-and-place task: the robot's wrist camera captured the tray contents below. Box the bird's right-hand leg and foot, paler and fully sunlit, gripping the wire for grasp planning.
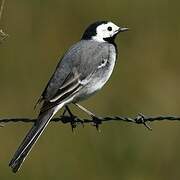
[75,103,102,132]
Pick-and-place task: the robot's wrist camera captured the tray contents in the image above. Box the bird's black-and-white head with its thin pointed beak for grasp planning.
[82,21,128,43]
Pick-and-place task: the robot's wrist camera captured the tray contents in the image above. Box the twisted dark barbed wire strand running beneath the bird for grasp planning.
[0,113,180,130]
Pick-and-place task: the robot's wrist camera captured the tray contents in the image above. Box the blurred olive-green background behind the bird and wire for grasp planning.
[0,0,180,180]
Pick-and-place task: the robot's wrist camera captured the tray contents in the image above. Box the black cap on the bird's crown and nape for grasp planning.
[81,21,108,40]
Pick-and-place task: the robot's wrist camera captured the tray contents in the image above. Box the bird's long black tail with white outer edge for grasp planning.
[9,107,59,172]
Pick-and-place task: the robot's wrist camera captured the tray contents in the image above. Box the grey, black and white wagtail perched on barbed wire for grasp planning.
[9,20,128,173]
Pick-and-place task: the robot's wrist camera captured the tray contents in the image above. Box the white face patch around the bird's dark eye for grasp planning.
[92,22,119,42]
